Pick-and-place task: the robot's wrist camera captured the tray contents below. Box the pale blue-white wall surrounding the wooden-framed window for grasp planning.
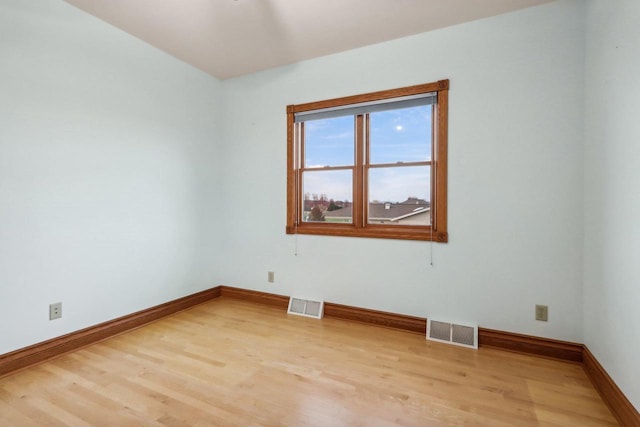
[221,1,584,342]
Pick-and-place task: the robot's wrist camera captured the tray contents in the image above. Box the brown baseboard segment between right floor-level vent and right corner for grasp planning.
[478,328,583,363]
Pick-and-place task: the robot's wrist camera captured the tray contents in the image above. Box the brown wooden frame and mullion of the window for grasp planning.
[286,80,449,243]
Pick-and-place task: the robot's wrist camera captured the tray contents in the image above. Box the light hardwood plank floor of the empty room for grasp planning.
[0,298,617,427]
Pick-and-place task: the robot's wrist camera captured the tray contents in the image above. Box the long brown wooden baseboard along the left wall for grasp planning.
[0,286,220,377]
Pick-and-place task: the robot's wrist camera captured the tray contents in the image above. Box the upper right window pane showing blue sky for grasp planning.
[369,105,432,164]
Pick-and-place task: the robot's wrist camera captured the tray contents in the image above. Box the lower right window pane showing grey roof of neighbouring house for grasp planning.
[367,166,431,225]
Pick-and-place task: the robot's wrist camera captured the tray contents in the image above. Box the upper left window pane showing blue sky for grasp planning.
[304,116,355,168]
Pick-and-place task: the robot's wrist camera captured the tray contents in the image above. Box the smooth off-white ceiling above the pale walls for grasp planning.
[66,0,552,79]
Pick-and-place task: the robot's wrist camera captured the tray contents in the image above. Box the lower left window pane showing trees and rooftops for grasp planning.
[302,170,353,223]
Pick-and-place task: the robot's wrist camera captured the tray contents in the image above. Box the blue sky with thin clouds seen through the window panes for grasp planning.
[303,106,431,202]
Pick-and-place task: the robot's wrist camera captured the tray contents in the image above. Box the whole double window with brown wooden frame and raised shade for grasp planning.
[287,80,449,242]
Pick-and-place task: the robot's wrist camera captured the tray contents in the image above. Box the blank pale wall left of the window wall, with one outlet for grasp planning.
[0,0,221,354]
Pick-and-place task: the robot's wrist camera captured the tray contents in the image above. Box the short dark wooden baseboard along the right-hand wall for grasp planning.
[583,346,640,427]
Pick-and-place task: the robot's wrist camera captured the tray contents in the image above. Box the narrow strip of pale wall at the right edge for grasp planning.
[584,0,640,409]
